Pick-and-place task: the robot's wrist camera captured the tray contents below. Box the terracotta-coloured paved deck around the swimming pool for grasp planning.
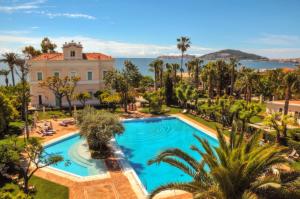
[32,114,216,199]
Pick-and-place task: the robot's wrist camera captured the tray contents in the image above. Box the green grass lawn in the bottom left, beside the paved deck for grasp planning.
[0,176,69,199]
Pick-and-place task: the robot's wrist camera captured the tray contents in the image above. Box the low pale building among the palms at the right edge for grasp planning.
[266,100,300,124]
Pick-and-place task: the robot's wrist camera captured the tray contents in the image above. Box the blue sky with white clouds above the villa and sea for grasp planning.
[0,0,300,58]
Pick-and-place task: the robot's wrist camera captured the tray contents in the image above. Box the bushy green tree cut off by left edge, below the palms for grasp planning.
[0,92,18,137]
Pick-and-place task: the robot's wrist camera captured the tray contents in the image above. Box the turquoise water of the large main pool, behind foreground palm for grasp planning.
[116,117,218,192]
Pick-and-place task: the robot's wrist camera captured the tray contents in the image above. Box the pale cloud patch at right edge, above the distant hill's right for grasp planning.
[253,34,300,46]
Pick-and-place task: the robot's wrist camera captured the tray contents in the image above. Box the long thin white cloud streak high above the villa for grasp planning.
[25,10,96,20]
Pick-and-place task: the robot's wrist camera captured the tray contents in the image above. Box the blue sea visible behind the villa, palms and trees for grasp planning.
[0,58,296,85]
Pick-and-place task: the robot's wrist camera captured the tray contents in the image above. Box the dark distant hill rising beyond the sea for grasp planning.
[200,49,268,60]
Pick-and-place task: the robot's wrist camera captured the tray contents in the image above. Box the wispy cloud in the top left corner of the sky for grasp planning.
[0,0,45,13]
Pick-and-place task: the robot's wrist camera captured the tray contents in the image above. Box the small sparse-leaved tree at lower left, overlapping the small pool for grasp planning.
[19,138,63,193]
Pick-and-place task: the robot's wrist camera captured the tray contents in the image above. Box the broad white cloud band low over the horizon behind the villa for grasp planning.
[0,35,214,57]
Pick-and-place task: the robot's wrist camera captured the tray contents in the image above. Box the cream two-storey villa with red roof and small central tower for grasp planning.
[29,41,114,107]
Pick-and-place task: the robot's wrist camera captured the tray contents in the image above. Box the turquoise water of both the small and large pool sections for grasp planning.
[45,117,218,192]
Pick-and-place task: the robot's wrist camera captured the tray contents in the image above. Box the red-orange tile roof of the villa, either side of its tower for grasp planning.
[32,53,112,61]
